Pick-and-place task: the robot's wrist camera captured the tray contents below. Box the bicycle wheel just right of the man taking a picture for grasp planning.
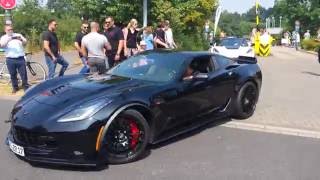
[26,62,47,84]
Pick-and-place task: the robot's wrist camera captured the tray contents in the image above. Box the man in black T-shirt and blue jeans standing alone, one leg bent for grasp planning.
[42,19,69,79]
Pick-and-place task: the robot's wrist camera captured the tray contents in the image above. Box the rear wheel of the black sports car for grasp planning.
[232,82,259,119]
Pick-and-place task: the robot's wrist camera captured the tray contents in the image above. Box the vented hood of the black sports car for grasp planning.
[29,75,151,108]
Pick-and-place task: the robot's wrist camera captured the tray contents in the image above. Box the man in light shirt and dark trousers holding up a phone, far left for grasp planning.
[0,25,29,94]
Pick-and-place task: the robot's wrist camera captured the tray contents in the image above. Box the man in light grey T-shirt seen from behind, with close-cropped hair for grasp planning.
[81,22,111,74]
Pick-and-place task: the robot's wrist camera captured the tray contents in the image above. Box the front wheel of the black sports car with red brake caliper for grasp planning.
[101,109,150,164]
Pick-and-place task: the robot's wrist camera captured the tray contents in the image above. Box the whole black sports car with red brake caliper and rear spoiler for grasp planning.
[7,51,262,166]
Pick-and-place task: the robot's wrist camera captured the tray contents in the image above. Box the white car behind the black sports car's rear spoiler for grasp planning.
[209,37,255,58]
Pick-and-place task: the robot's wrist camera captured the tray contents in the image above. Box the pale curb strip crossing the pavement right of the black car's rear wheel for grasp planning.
[222,121,320,139]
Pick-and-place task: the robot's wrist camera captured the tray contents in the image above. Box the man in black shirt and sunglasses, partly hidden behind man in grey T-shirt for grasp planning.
[74,22,90,74]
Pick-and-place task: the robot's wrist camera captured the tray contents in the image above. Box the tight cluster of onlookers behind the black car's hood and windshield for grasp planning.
[75,17,177,74]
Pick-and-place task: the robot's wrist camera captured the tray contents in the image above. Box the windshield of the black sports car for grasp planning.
[108,53,183,82]
